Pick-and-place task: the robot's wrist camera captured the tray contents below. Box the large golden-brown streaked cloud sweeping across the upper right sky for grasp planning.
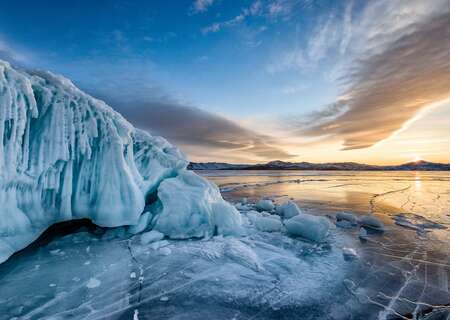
[298,6,450,150]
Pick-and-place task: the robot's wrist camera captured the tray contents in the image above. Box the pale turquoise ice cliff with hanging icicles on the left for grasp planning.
[0,60,241,262]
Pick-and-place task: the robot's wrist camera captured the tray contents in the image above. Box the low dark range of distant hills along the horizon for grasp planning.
[188,160,450,171]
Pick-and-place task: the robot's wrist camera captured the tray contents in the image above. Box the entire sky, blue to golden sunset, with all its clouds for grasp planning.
[0,0,450,164]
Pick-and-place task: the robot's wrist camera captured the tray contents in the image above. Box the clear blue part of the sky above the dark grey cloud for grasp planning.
[0,1,342,116]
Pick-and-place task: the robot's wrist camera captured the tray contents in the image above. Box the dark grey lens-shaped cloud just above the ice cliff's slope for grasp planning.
[107,100,293,161]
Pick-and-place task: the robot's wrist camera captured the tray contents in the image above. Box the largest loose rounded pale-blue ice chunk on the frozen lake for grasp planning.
[284,214,330,242]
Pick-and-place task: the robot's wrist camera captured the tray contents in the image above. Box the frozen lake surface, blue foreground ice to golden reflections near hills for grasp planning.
[0,171,450,320]
